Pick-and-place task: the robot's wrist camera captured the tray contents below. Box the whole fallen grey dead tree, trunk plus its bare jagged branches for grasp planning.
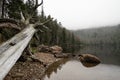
[0,0,51,80]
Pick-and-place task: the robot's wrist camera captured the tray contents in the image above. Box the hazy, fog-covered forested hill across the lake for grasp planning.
[74,25,120,44]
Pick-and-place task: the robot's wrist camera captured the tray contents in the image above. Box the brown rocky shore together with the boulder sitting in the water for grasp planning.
[4,45,101,80]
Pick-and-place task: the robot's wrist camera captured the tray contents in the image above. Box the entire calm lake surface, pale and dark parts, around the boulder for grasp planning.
[43,47,120,80]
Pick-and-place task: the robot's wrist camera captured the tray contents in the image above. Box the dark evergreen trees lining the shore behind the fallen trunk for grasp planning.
[0,0,80,52]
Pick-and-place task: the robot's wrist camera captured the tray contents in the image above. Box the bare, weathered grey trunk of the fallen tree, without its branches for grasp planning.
[0,24,35,80]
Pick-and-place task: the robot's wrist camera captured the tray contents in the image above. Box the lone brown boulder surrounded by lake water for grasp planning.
[79,54,101,64]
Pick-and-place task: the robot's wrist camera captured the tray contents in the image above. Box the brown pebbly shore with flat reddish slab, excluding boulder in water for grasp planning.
[4,47,62,80]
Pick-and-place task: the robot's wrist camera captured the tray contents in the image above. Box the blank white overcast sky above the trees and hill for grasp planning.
[39,0,120,30]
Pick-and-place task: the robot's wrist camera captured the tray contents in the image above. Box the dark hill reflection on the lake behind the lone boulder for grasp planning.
[78,45,120,65]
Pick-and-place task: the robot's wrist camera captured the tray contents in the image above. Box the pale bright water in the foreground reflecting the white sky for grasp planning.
[44,60,120,80]
